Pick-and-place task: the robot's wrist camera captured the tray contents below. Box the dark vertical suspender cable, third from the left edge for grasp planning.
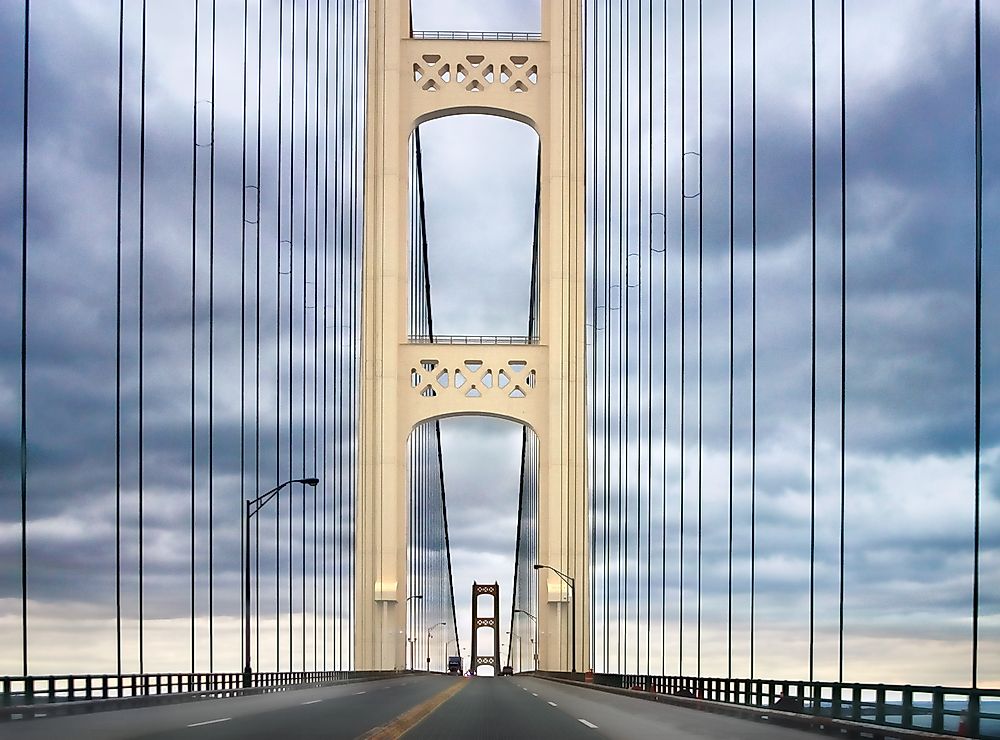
[139,0,146,673]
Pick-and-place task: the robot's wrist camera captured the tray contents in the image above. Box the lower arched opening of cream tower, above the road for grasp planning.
[407,415,538,675]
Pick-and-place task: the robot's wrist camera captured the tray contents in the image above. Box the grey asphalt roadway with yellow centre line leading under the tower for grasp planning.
[0,675,815,740]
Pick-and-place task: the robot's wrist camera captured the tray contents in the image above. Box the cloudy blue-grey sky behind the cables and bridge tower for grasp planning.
[0,0,1000,685]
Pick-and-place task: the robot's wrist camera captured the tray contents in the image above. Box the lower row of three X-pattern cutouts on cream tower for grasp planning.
[410,359,537,400]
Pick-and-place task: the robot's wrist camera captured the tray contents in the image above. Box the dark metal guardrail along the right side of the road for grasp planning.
[537,671,1000,740]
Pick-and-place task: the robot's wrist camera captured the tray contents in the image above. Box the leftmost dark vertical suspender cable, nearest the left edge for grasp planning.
[20,0,31,676]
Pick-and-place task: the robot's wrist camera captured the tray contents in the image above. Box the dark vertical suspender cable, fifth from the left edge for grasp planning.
[208,0,217,672]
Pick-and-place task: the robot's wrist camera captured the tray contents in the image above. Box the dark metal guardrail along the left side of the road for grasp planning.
[0,671,392,708]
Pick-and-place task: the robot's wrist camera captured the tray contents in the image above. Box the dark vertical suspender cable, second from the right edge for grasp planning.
[837,0,847,683]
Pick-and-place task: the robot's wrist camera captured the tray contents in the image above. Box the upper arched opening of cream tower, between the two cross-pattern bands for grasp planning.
[409,113,539,339]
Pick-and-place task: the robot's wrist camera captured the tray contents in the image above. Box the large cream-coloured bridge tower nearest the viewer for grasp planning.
[355,0,590,670]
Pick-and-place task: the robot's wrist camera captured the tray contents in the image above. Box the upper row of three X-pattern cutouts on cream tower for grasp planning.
[413,54,538,94]
